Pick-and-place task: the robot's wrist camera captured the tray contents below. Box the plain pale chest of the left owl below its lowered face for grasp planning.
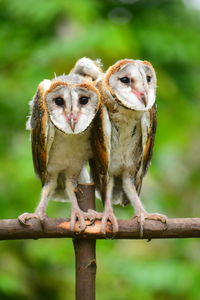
[47,131,91,175]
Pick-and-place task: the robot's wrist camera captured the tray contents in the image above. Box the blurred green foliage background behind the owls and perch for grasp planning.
[0,0,200,300]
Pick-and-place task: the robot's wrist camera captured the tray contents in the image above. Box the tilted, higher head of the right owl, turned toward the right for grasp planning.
[103,59,156,111]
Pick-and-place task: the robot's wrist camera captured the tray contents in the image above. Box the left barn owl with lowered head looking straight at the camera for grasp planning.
[18,74,100,231]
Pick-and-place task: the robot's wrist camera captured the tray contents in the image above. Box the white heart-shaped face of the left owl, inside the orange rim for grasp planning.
[46,83,99,134]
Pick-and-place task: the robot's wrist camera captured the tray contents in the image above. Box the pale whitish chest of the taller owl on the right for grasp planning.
[109,110,142,176]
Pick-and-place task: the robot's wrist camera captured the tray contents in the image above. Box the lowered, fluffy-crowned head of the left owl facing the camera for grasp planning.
[40,76,100,134]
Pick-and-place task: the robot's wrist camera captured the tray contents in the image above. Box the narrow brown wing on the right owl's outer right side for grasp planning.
[135,105,157,194]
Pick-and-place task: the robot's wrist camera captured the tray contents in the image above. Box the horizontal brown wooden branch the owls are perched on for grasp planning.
[0,218,200,240]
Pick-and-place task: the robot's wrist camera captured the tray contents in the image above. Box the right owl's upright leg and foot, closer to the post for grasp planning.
[101,177,118,235]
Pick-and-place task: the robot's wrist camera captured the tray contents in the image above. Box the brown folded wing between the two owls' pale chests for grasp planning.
[90,106,111,201]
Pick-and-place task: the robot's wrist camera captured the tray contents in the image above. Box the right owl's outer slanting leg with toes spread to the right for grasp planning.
[123,176,167,238]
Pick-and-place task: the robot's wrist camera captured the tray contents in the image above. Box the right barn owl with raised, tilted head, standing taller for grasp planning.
[93,59,167,237]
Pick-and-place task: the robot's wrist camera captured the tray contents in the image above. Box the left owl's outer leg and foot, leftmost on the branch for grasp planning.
[18,174,57,225]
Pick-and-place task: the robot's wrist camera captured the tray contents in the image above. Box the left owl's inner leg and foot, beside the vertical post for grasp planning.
[66,179,86,231]
